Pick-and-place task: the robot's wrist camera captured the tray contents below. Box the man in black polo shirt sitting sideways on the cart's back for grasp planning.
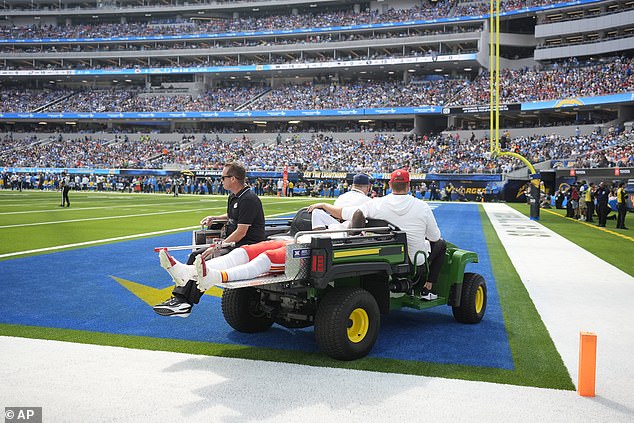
[154,162,266,317]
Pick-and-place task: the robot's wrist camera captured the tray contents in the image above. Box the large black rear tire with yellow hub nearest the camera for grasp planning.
[315,287,381,360]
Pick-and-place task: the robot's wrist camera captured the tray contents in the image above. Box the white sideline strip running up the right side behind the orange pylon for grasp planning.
[478,204,634,408]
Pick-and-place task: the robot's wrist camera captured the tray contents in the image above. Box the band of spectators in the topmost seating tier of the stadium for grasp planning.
[0,0,576,39]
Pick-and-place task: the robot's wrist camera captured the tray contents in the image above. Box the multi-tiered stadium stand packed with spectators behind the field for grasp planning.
[0,0,634,195]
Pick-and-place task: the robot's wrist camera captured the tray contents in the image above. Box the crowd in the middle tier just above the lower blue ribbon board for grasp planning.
[0,57,634,112]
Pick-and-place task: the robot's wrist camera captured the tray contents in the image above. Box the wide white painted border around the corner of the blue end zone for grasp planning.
[0,203,634,423]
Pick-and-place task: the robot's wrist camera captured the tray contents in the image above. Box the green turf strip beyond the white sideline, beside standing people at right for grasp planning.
[509,203,634,276]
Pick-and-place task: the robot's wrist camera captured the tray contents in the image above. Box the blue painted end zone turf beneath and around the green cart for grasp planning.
[0,203,514,369]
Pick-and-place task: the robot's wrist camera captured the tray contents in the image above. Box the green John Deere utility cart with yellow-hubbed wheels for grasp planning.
[217,219,486,360]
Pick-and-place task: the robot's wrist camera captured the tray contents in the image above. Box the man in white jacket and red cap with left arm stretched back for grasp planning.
[308,169,446,300]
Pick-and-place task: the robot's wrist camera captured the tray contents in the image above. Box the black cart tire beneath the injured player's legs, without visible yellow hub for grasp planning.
[222,288,273,333]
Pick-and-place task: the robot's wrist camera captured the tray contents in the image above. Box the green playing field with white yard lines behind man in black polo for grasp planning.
[0,191,314,255]
